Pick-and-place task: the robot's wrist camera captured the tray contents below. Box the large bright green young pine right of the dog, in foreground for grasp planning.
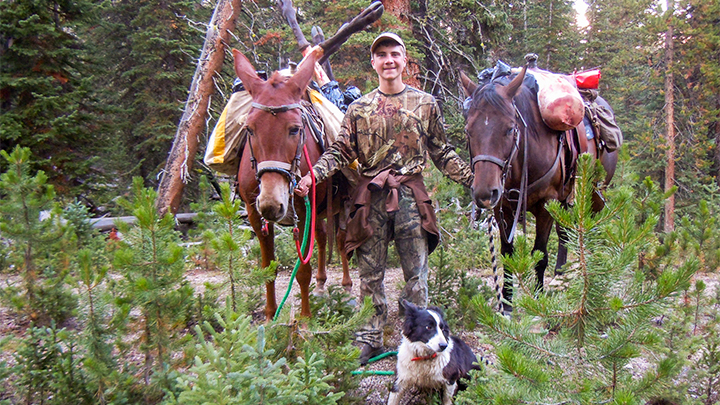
[463,155,698,404]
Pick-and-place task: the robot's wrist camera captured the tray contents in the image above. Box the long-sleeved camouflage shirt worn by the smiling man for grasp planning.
[313,86,473,187]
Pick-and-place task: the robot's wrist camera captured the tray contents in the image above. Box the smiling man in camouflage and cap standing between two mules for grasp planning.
[295,33,472,364]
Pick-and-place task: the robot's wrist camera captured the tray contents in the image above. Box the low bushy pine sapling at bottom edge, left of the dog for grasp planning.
[164,302,354,405]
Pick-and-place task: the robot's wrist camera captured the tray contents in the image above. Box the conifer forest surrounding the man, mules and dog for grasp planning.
[0,0,720,405]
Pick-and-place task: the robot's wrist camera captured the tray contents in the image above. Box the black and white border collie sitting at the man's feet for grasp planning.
[388,300,480,405]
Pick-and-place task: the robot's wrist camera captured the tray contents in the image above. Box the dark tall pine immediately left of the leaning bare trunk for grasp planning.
[88,0,211,186]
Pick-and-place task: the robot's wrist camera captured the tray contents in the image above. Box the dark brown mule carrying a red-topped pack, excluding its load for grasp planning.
[461,66,617,313]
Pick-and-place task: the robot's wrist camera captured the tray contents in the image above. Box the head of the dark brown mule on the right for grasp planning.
[460,68,525,209]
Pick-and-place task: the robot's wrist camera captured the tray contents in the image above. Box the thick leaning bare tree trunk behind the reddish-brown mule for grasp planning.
[157,0,242,214]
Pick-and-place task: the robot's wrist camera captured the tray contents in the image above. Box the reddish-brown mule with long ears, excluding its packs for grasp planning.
[233,48,352,321]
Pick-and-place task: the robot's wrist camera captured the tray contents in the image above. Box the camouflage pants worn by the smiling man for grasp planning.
[355,185,428,347]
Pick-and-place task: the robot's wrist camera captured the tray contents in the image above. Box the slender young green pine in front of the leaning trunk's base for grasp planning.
[113,177,193,399]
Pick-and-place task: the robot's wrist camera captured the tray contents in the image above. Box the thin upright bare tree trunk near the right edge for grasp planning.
[664,22,675,232]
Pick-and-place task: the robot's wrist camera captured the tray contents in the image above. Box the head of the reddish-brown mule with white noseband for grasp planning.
[233,48,323,222]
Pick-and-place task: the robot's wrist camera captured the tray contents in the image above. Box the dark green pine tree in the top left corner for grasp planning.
[0,0,99,193]
